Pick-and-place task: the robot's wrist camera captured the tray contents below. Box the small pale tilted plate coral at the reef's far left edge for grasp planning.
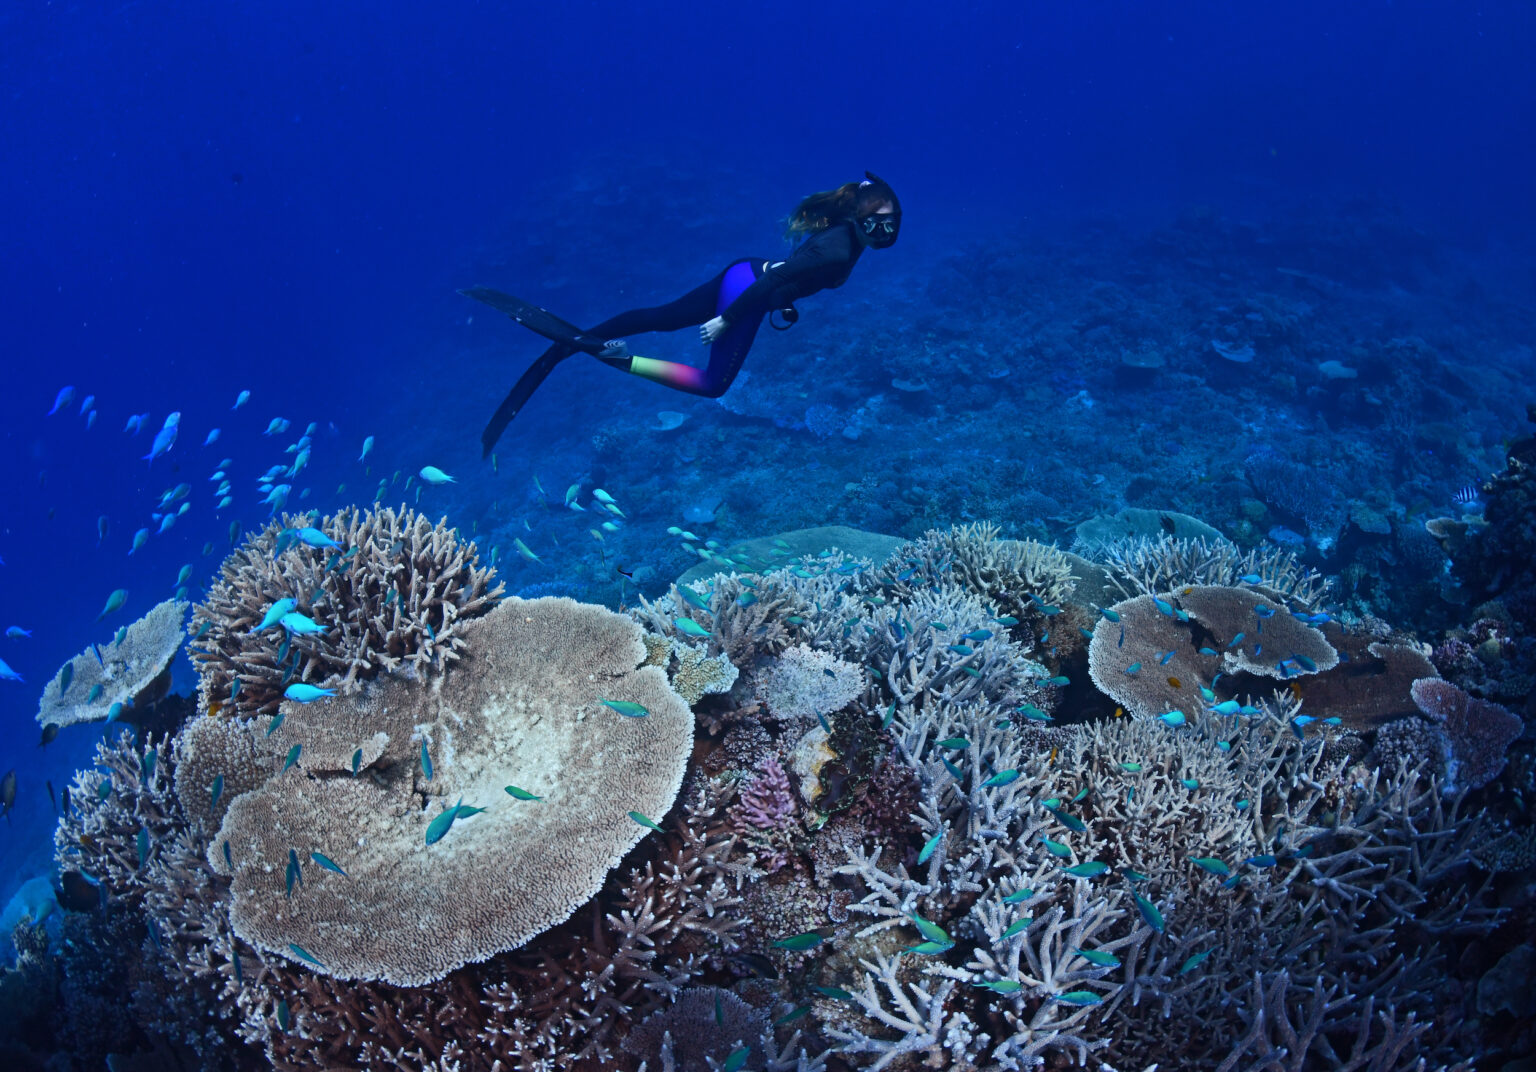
[37,599,187,726]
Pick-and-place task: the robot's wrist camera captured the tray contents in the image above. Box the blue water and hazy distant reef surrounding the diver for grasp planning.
[0,0,1536,1062]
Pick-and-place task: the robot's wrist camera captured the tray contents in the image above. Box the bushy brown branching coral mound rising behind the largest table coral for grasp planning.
[189,507,501,716]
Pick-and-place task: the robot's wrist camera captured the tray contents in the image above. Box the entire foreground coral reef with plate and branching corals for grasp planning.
[6,460,1536,1072]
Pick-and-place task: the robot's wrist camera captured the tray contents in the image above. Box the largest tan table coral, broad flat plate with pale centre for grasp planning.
[209,597,693,986]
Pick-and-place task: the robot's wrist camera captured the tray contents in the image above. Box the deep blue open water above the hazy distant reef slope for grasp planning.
[0,0,1536,897]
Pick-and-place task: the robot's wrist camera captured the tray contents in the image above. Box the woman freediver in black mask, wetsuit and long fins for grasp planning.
[462,172,902,456]
